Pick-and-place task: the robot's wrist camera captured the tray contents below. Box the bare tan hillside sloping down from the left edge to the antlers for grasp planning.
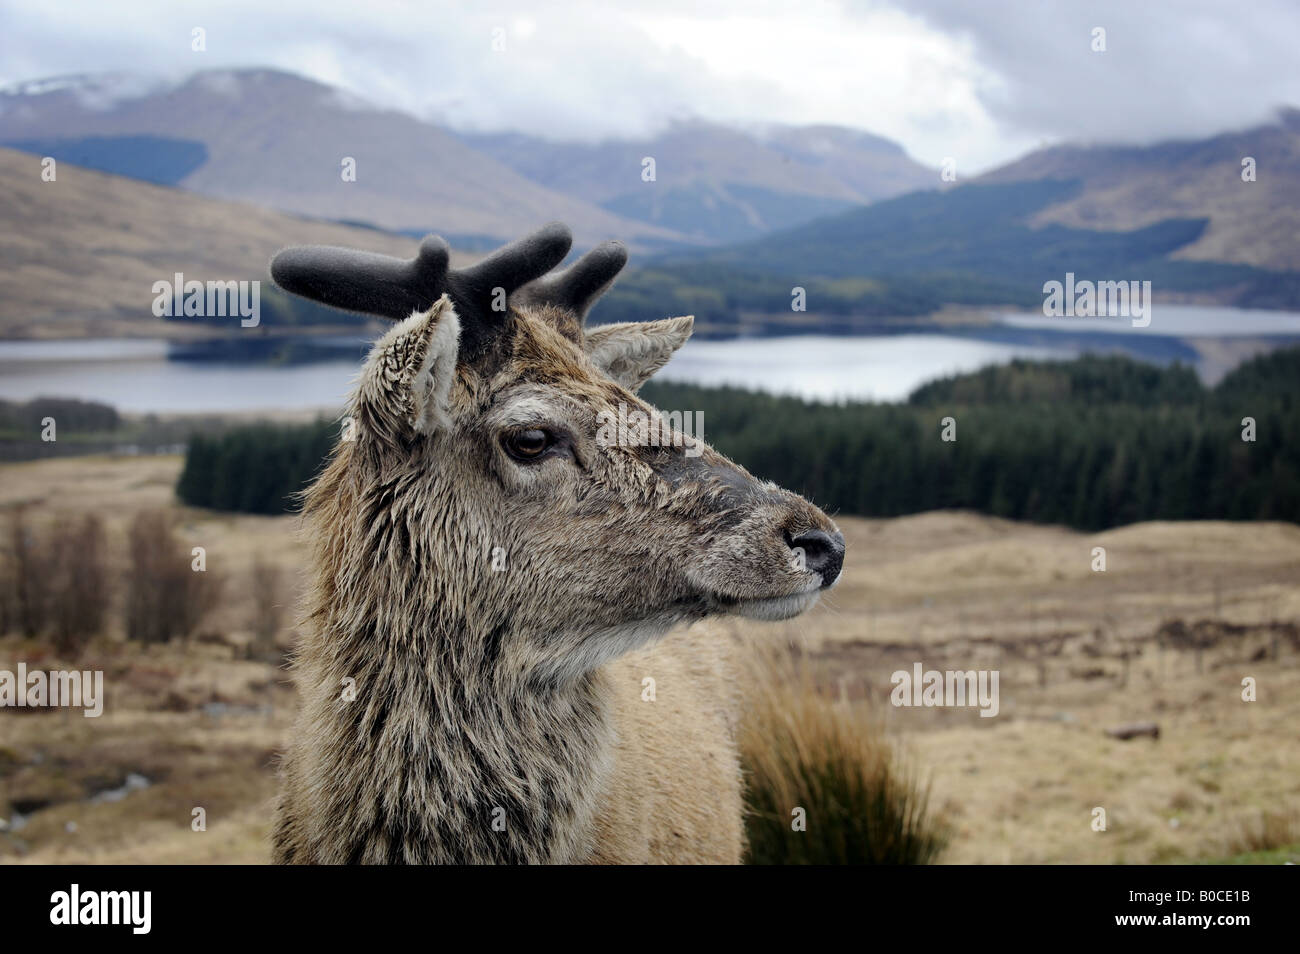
[0,141,452,338]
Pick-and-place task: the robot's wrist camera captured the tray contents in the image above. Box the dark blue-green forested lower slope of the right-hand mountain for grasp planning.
[594,179,1300,331]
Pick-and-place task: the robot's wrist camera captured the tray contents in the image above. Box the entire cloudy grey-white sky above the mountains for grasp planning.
[0,0,1300,172]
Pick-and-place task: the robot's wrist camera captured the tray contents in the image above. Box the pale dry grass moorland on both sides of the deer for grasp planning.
[0,458,1300,863]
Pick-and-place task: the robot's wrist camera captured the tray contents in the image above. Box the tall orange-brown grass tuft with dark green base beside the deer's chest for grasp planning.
[740,649,948,864]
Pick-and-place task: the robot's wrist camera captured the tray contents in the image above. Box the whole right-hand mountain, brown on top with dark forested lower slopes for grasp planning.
[595,110,1300,330]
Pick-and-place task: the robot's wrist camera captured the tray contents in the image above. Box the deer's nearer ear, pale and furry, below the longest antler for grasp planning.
[358,295,460,438]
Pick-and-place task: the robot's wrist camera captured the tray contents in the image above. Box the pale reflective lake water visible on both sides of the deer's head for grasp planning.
[0,305,1300,413]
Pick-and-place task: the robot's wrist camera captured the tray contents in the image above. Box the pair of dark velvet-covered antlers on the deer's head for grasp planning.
[270,222,628,356]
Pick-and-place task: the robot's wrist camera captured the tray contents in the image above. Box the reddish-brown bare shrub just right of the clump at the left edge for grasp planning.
[125,511,221,643]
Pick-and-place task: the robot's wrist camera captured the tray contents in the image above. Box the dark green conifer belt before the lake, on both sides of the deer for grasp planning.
[178,348,1300,530]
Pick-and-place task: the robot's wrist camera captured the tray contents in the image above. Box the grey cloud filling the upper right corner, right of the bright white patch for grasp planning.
[889,0,1300,143]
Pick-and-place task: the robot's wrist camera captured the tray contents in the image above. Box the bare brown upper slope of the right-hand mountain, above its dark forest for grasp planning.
[978,109,1300,270]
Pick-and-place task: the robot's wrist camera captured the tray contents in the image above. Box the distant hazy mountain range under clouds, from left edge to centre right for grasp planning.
[0,69,937,251]
